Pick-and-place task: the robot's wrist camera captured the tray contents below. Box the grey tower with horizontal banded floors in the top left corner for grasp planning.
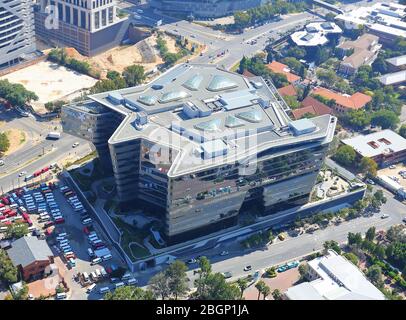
[0,0,36,70]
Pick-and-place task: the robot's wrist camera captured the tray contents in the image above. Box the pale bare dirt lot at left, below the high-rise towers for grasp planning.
[0,61,97,112]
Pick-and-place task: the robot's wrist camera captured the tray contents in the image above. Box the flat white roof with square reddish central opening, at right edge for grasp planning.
[342,129,406,158]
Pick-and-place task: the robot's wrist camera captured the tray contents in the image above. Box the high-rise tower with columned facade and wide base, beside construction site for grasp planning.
[35,0,129,56]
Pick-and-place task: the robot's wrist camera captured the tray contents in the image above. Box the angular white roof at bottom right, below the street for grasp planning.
[285,250,385,300]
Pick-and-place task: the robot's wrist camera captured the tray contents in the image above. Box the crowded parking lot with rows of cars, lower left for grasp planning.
[0,175,137,300]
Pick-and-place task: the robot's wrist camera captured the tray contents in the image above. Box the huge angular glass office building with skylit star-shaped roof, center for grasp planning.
[62,64,336,243]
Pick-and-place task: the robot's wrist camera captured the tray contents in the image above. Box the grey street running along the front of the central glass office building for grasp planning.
[135,187,406,286]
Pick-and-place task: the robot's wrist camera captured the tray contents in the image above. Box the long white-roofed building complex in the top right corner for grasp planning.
[336,2,406,37]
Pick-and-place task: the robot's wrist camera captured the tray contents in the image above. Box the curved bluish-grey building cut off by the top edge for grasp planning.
[150,0,266,18]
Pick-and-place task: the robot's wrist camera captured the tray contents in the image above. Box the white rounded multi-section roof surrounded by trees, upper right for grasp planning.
[290,22,343,47]
